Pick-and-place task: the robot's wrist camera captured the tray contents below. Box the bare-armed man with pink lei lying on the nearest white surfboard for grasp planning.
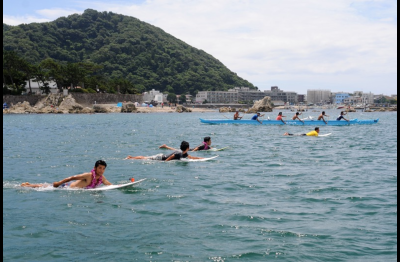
[21,160,112,188]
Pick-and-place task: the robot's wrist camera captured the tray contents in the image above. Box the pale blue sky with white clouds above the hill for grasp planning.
[3,0,397,95]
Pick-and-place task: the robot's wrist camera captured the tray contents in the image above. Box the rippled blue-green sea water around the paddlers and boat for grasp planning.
[3,110,397,262]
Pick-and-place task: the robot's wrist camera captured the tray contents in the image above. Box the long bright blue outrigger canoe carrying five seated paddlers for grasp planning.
[200,118,379,126]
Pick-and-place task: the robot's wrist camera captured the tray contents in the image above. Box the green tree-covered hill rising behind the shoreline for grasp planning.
[3,9,257,95]
